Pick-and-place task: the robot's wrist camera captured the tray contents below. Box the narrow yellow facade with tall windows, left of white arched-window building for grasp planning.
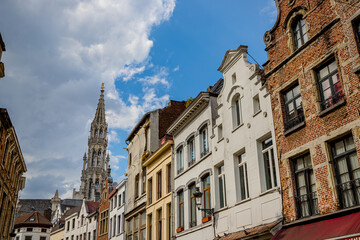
[144,137,174,240]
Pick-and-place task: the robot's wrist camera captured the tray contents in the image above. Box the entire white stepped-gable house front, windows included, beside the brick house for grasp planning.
[211,46,282,239]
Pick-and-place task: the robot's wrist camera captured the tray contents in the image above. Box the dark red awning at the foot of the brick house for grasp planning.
[271,212,360,240]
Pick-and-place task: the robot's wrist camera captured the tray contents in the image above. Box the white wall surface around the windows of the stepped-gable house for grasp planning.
[212,45,282,236]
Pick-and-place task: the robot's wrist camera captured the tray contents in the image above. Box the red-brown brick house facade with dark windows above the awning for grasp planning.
[264,0,360,238]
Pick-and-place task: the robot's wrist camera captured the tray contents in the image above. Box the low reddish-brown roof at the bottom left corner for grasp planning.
[14,211,52,228]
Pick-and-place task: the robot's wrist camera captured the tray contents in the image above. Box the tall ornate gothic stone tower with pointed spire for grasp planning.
[73,83,111,201]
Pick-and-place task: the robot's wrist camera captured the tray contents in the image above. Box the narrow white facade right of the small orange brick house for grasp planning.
[108,179,127,240]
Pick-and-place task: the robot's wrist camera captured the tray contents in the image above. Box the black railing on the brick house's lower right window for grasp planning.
[336,179,360,208]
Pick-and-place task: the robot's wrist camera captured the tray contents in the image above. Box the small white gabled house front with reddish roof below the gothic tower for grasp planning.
[64,200,99,240]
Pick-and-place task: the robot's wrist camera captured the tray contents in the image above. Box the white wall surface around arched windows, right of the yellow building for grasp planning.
[173,94,216,240]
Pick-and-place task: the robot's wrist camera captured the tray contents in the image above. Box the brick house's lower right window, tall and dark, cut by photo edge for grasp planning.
[331,135,360,208]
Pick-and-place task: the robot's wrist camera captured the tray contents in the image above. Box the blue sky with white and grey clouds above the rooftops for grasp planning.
[0,0,277,199]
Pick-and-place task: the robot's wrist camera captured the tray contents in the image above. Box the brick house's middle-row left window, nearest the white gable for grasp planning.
[283,83,304,130]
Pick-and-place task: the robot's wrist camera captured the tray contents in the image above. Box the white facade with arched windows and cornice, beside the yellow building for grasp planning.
[168,79,222,240]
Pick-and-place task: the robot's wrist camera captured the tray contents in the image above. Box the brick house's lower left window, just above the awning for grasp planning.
[293,154,319,218]
